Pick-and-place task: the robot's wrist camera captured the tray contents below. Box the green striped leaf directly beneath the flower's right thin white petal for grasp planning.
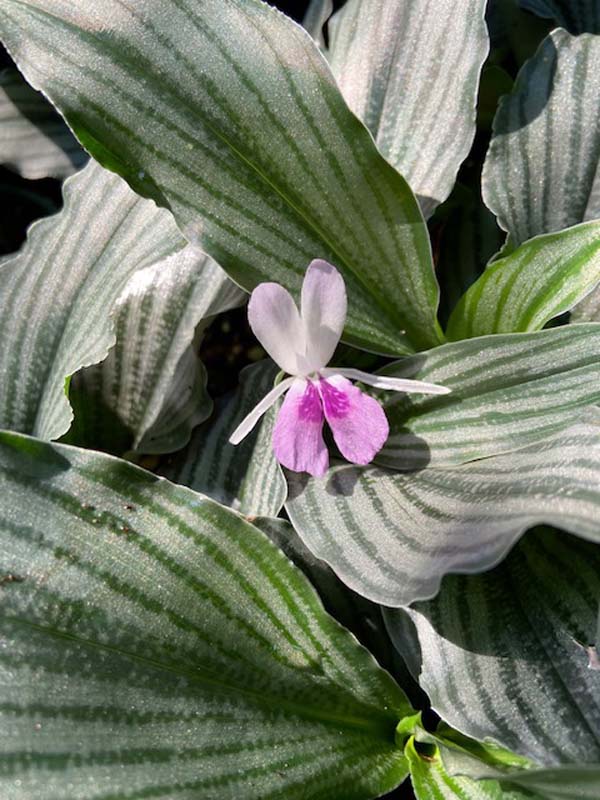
[376,324,600,470]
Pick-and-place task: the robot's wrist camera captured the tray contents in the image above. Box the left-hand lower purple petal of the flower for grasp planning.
[273,380,329,478]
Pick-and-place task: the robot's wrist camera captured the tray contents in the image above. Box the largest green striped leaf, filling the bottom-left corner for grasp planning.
[0,434,414,800]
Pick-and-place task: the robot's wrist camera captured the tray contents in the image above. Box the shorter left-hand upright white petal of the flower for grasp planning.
[248,283,306,375]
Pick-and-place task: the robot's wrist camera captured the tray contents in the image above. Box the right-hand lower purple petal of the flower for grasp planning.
[319,375,390,464]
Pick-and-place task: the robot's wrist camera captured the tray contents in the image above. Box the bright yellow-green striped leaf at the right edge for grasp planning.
[447,222,600,340]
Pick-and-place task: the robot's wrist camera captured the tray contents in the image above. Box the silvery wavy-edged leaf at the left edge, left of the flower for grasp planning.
[0,163,185,439]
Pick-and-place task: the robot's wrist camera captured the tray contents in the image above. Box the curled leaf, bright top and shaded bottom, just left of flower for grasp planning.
[68,246,245,454]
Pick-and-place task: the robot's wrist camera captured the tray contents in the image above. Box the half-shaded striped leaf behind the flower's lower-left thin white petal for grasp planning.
[159,360,287,517]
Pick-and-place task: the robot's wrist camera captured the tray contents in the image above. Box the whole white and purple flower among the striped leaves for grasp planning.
[229,259,450,477]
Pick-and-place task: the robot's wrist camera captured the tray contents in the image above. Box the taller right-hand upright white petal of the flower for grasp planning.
[300,259,348,371]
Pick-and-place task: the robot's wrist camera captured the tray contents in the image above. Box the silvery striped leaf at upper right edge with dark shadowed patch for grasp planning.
[482,29,600,245]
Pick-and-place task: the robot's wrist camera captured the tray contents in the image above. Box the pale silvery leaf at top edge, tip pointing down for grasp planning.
[329,0,489,216]
